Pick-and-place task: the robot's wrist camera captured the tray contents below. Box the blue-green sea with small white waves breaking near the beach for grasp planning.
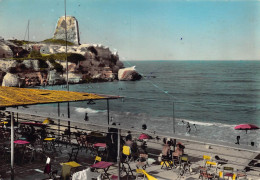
[30,60,260,146]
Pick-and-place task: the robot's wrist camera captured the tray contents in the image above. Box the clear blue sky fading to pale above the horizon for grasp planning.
[0,0,260,60]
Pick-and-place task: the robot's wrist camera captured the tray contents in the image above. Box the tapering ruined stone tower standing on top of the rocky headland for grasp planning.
[53,16,80,45]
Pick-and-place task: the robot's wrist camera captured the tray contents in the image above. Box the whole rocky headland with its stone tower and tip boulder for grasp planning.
[0,16,142,87]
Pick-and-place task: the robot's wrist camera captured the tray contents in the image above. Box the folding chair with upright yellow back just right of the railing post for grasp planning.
[121,146,134,176]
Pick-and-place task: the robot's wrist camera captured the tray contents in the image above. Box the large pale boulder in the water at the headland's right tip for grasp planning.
[118,66,142,81]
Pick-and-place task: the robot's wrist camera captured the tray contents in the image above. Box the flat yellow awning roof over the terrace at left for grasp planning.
[0,86,119,107]
